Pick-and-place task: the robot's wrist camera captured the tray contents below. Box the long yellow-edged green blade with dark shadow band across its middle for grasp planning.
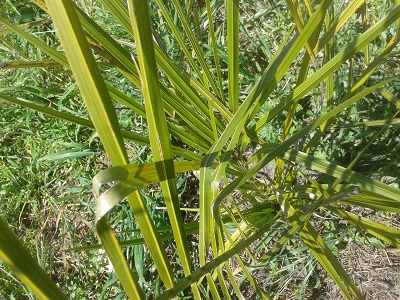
[128,0,195,288]
